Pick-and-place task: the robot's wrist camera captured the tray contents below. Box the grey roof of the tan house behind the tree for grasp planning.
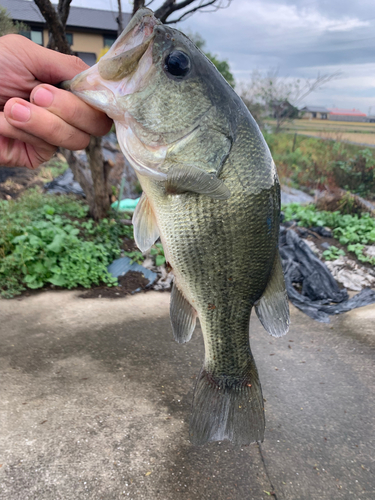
[1,0,131,31]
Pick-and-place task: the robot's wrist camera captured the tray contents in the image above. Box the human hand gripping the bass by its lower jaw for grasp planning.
[0,35,112,169]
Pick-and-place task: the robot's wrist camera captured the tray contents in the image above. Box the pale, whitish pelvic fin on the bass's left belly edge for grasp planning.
[133,193,159,252]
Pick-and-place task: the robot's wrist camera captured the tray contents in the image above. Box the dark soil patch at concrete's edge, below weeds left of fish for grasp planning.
[79,271,149,299]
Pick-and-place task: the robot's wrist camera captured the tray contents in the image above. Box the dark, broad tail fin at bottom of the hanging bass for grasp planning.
[190,359,265,445]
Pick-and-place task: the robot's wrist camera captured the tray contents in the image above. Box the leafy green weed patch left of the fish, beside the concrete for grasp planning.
[0,191,132,297]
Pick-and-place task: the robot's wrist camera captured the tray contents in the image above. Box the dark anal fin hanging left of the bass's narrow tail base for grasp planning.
[170,283,197,344]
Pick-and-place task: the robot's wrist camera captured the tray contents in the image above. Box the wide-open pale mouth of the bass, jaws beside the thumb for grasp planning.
[65,9,162,120]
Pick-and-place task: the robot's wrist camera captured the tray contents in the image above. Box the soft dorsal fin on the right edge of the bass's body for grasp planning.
[255,252,289,337]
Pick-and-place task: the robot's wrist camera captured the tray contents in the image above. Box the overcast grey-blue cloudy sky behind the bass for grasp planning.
[72,0,375,114]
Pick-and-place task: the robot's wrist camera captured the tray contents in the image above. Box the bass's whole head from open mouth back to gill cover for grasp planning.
[70,9,229,176]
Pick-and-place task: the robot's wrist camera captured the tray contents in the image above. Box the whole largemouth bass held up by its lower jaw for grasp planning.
[70,9,289,444]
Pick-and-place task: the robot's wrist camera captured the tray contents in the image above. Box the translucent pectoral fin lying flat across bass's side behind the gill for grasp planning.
[165,165,230,200]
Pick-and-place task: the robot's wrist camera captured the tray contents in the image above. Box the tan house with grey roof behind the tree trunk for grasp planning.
[0,0,131,66]
